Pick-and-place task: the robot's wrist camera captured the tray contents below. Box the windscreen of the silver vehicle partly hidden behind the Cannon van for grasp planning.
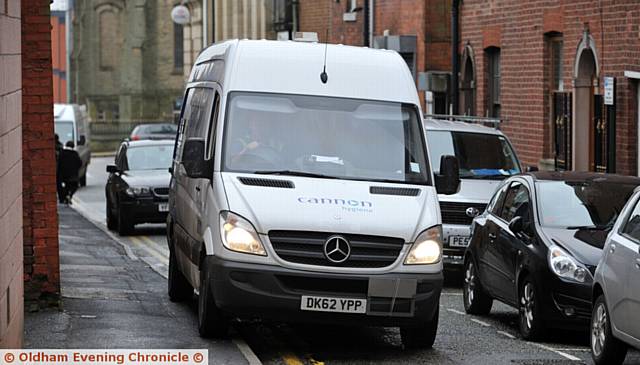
[427,130,520,179]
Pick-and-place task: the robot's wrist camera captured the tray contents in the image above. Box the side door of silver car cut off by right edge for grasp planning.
[616,201,640,341]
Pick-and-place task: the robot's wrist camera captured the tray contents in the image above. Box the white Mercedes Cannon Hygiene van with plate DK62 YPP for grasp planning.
[167,40,459,347]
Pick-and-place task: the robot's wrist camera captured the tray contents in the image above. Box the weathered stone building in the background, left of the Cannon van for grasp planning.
[71,0,190,121]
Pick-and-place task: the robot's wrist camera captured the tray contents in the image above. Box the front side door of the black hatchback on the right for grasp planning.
[487,180,530,303]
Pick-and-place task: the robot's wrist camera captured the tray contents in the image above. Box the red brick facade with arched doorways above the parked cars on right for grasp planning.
[460,0,640,175]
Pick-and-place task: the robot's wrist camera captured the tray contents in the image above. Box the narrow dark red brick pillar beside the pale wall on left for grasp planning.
[22,0,60,305]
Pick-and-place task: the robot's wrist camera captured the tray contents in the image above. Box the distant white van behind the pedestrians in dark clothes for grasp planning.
[53,104,91,186]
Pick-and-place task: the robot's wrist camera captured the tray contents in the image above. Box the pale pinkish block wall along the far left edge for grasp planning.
[0,0,24,348]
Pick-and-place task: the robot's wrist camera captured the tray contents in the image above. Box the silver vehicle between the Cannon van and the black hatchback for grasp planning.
[425,117,521,270]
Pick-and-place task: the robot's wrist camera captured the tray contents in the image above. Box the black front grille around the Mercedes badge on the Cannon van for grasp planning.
[269,231,404,268]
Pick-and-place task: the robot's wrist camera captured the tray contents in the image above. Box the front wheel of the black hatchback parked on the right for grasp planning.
[518,277,545,341]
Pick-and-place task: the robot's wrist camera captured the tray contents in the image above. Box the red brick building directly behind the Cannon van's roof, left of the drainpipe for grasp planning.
[297,0,451,113]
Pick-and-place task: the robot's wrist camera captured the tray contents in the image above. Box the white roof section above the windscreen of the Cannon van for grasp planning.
[190,40,420,105]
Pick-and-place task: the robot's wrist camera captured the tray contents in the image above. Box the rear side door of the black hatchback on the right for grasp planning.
[476,183,511,295]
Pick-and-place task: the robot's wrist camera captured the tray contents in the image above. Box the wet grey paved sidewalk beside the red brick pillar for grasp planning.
[25,206,247,364]
